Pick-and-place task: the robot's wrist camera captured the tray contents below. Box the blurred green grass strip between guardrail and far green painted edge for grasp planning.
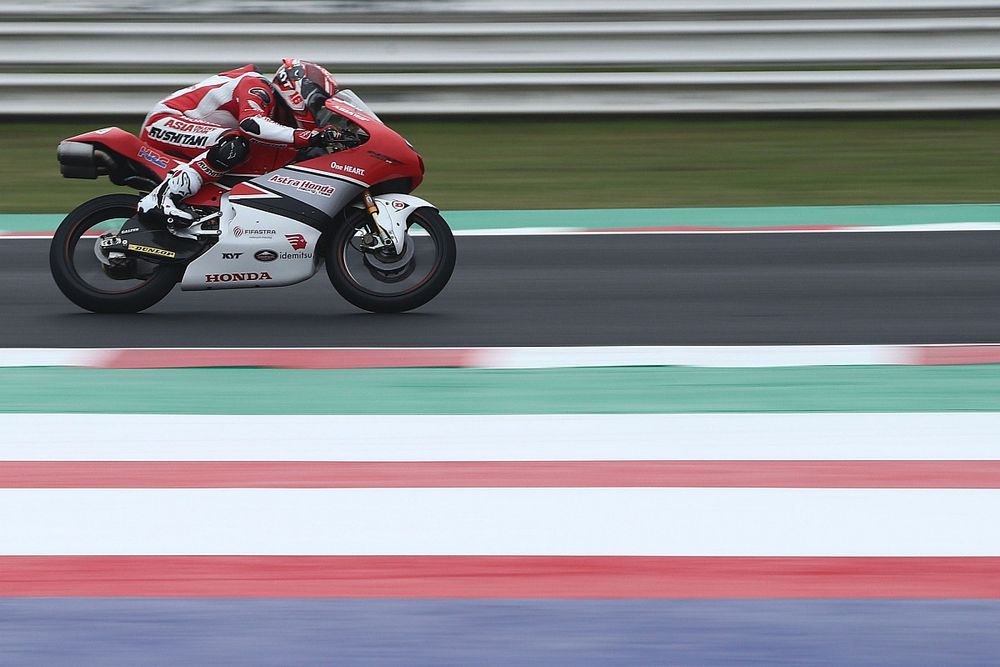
[0,117,1000,213]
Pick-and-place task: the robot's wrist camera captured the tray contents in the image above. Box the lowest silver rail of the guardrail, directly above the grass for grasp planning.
[7,69,1000,115]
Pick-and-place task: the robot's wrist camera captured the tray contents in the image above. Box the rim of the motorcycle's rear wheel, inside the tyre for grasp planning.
[64,207,156,295]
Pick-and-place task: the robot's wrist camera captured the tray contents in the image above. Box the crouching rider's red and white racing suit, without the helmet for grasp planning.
[139,65,317,220]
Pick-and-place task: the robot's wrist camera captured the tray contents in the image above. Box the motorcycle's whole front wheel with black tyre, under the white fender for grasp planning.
[326,207,456,313]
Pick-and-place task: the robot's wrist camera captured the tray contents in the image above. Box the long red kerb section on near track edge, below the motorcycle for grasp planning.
[102,348,479,369]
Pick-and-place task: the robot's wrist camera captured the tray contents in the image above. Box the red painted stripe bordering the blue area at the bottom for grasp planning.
[0,556,1000,598]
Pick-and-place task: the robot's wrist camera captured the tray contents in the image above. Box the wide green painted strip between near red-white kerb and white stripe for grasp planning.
[0,365,1000,412]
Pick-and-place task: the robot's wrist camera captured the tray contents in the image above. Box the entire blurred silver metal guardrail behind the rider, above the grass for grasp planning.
[0,0,1000,115]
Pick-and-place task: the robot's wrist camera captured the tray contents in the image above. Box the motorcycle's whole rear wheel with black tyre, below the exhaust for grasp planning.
[49,194,184,313]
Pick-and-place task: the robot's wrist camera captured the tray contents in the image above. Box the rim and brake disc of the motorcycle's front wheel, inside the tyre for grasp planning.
[339,214,443,298]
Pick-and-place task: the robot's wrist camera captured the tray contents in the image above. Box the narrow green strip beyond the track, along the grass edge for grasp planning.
[0,204,1000,232]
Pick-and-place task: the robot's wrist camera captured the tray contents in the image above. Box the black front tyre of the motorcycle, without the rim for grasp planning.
[326,207,457,313]
